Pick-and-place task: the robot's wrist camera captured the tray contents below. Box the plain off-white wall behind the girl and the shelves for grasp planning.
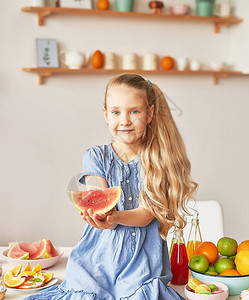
[0,0,249,246]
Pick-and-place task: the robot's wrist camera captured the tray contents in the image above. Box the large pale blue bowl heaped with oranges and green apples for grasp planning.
[189,237,249,295]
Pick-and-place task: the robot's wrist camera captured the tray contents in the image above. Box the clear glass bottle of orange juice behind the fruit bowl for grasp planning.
[187,213,202,260]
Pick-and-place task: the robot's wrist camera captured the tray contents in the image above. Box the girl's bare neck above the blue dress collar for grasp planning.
[112,141,139,163]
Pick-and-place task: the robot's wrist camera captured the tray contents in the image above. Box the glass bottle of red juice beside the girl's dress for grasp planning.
[170,228,189,285]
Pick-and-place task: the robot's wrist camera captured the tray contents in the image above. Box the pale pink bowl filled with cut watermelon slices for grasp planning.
[2,239,64,269]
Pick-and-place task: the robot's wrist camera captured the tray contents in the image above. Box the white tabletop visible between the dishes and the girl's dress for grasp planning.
[0,247,239,300]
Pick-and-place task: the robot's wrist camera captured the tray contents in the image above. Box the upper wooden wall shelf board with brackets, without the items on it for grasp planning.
[21,6,243,33]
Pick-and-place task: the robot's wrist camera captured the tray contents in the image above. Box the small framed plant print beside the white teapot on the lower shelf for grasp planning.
[36,39,59,68]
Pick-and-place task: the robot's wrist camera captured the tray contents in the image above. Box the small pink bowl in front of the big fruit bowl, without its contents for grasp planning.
[184,281,228,300]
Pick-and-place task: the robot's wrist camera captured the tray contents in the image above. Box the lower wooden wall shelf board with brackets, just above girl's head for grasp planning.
[22,68,246,84]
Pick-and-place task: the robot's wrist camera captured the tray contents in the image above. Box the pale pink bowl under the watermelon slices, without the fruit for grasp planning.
[2,247,64,269]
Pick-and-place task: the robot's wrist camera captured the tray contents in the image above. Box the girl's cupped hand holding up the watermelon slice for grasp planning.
[80,208,117,230]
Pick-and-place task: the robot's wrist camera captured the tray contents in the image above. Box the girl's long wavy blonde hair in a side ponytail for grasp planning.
[106,74,198,239]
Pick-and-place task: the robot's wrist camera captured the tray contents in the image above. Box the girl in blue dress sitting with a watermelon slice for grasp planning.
[24,74,197,300]
